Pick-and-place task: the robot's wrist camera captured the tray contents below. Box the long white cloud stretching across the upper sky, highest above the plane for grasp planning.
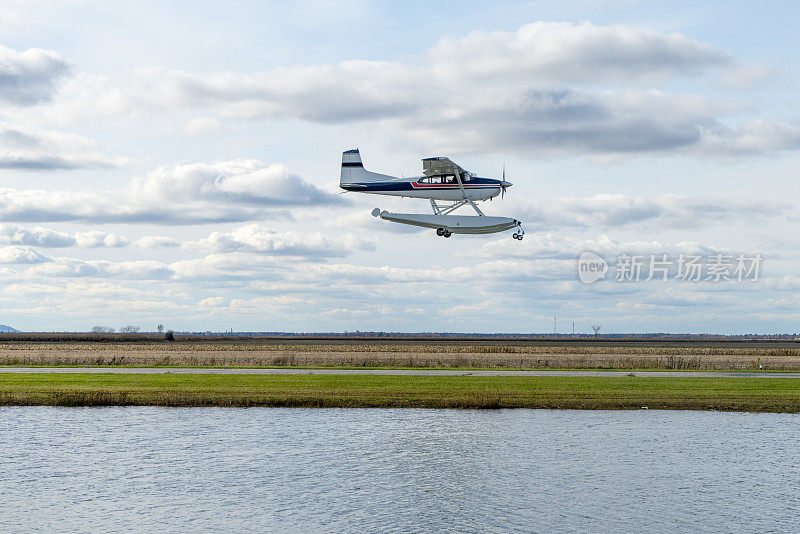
[120,22,730,122]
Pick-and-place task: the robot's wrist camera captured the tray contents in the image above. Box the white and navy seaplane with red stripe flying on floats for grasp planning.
[339,148,525,241]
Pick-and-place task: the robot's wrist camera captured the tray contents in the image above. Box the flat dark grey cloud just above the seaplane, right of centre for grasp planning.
[406,89,732,155]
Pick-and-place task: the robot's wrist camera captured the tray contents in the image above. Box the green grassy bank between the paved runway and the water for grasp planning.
[0,373,800,412]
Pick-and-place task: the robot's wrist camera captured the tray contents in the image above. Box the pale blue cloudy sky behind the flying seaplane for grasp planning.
[0,0,800,334]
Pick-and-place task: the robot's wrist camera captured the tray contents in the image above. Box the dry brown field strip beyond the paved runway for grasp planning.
[0,334,800,371]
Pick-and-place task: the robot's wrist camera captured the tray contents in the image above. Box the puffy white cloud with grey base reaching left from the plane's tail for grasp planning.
[0,160,342,224]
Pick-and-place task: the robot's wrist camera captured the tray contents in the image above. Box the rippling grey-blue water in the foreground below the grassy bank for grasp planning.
[0,407,800,532]
